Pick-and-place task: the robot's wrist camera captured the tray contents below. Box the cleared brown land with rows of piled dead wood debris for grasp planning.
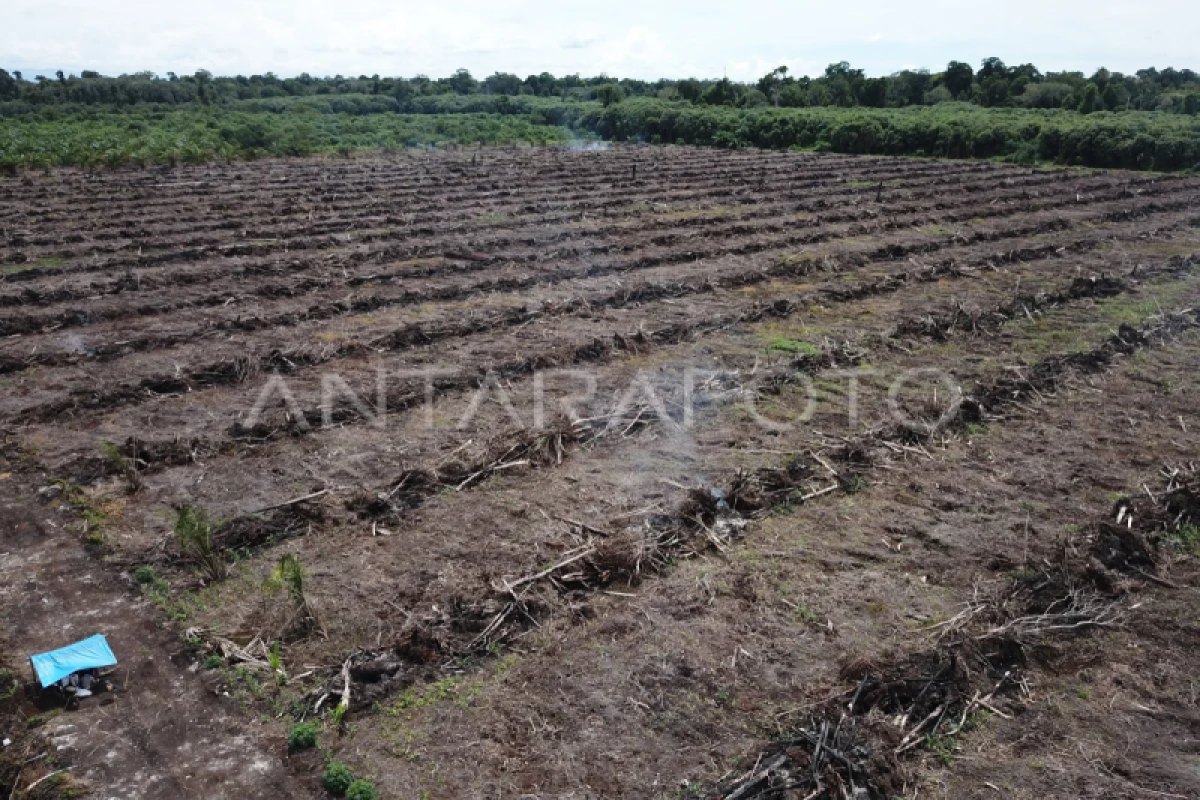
[0,146,1200,798]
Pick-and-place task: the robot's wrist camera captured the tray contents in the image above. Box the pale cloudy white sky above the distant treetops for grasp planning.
[0,0,1200,80]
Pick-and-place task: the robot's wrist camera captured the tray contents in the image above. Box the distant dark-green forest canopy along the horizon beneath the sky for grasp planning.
[0,58,1200,116]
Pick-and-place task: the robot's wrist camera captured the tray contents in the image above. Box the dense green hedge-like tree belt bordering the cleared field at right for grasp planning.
[571,98,1200,172]
